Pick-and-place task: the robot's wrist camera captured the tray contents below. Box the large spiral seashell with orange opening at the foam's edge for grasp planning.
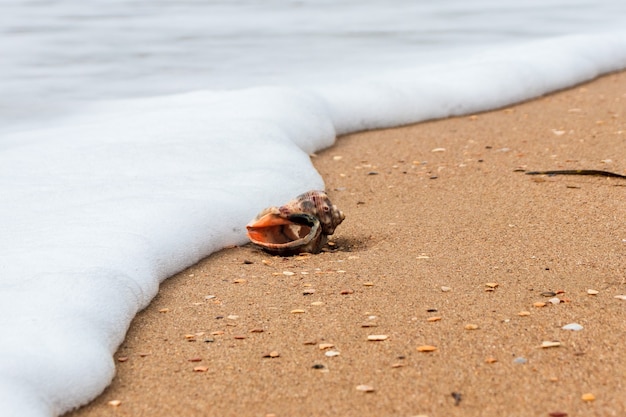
[246,191,345,256]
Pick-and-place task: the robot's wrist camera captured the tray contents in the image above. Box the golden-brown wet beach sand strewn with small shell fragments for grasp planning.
[69,73,626,417]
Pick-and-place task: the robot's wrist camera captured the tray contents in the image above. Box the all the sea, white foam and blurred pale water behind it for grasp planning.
[0,0,626,417]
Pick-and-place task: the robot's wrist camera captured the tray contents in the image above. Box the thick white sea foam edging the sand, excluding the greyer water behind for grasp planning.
[0,12,626,417]
